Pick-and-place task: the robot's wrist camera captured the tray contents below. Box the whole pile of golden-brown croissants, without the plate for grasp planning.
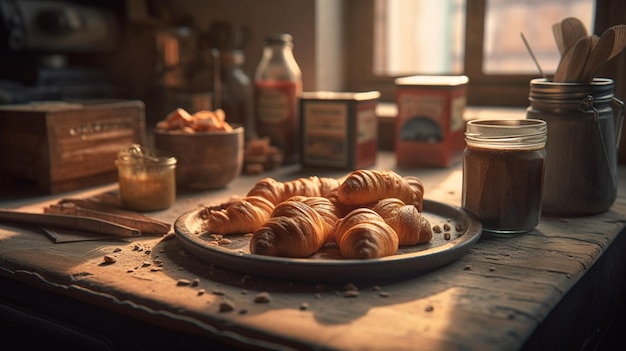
[200,170,432,258]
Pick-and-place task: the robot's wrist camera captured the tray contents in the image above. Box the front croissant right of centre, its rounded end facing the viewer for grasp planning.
[334,207,399,259]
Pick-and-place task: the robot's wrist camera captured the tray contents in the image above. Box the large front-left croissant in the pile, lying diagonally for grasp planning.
[250,198,338,258]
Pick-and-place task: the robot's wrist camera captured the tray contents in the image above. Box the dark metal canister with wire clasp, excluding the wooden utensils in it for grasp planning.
[527,78,624,216]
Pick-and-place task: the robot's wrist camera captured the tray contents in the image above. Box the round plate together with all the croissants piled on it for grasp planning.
[174,170,482,281]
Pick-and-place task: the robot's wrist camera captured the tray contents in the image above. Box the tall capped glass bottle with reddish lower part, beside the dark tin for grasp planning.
[254,34,302,164]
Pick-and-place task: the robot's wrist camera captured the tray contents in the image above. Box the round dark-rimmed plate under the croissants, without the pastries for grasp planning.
[174,200,482,282]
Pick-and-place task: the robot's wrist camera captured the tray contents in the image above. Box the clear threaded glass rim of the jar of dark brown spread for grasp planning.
[465,119,548,149]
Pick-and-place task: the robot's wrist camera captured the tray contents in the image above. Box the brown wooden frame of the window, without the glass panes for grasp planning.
[344,0,626,106]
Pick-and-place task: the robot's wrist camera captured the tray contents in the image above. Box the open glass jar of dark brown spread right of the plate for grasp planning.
[462,119,547,234]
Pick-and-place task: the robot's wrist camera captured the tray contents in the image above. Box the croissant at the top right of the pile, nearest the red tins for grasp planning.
[338,170,422,208]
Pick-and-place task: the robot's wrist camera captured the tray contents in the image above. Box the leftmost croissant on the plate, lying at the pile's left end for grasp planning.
[206,196,274,234]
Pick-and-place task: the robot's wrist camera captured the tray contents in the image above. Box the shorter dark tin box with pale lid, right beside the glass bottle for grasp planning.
[300,91,380,170]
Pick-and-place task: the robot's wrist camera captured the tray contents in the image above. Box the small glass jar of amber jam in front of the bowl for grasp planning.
[115,144,176,212]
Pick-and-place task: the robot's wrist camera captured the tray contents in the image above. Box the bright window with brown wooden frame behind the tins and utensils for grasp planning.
[346,0,604,106]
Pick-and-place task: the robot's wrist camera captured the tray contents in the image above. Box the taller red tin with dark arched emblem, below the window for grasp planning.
[395,76,469,167]
